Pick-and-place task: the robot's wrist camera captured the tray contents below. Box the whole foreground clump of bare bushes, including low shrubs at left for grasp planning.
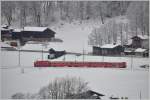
[11,76,89,99]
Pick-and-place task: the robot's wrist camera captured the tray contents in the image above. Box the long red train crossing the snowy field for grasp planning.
[34,61,126,68]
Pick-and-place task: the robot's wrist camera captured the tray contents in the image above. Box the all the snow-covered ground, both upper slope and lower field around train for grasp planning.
[0,18,149,99]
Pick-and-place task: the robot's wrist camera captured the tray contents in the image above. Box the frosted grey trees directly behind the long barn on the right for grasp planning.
[89,16,131,46]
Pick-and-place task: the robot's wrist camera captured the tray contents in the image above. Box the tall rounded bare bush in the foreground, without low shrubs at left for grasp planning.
[39,77,88,99]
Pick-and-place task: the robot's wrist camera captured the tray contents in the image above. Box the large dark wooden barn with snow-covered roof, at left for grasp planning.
[12,27,55,41]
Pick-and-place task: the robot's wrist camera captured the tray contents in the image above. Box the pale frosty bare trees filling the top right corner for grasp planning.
[126,1,149,35]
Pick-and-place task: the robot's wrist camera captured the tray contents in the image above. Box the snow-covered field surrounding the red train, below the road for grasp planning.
[1,51,149,99]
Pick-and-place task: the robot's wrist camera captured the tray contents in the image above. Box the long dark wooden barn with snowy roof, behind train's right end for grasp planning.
[93,44,124,56]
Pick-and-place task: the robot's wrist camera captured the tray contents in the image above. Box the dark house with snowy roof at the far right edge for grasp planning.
[131,35,149,49]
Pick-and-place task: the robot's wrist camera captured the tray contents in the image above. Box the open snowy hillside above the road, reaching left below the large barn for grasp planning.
[21,20,101,53]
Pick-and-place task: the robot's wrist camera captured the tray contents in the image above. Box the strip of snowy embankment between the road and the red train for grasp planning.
[1,51,149,70]
